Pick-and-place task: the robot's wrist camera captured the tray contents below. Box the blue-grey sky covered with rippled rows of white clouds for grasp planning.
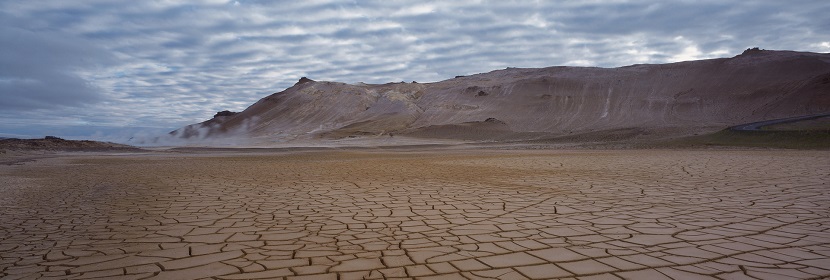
[0,0,830,142]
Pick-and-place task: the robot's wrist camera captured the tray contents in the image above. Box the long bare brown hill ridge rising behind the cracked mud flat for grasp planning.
[172,51,830,144]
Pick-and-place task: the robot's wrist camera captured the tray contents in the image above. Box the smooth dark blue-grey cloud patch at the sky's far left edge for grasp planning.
[0,21,111,110]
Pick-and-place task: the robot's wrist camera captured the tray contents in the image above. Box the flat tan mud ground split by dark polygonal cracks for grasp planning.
[0,150,830,279]
